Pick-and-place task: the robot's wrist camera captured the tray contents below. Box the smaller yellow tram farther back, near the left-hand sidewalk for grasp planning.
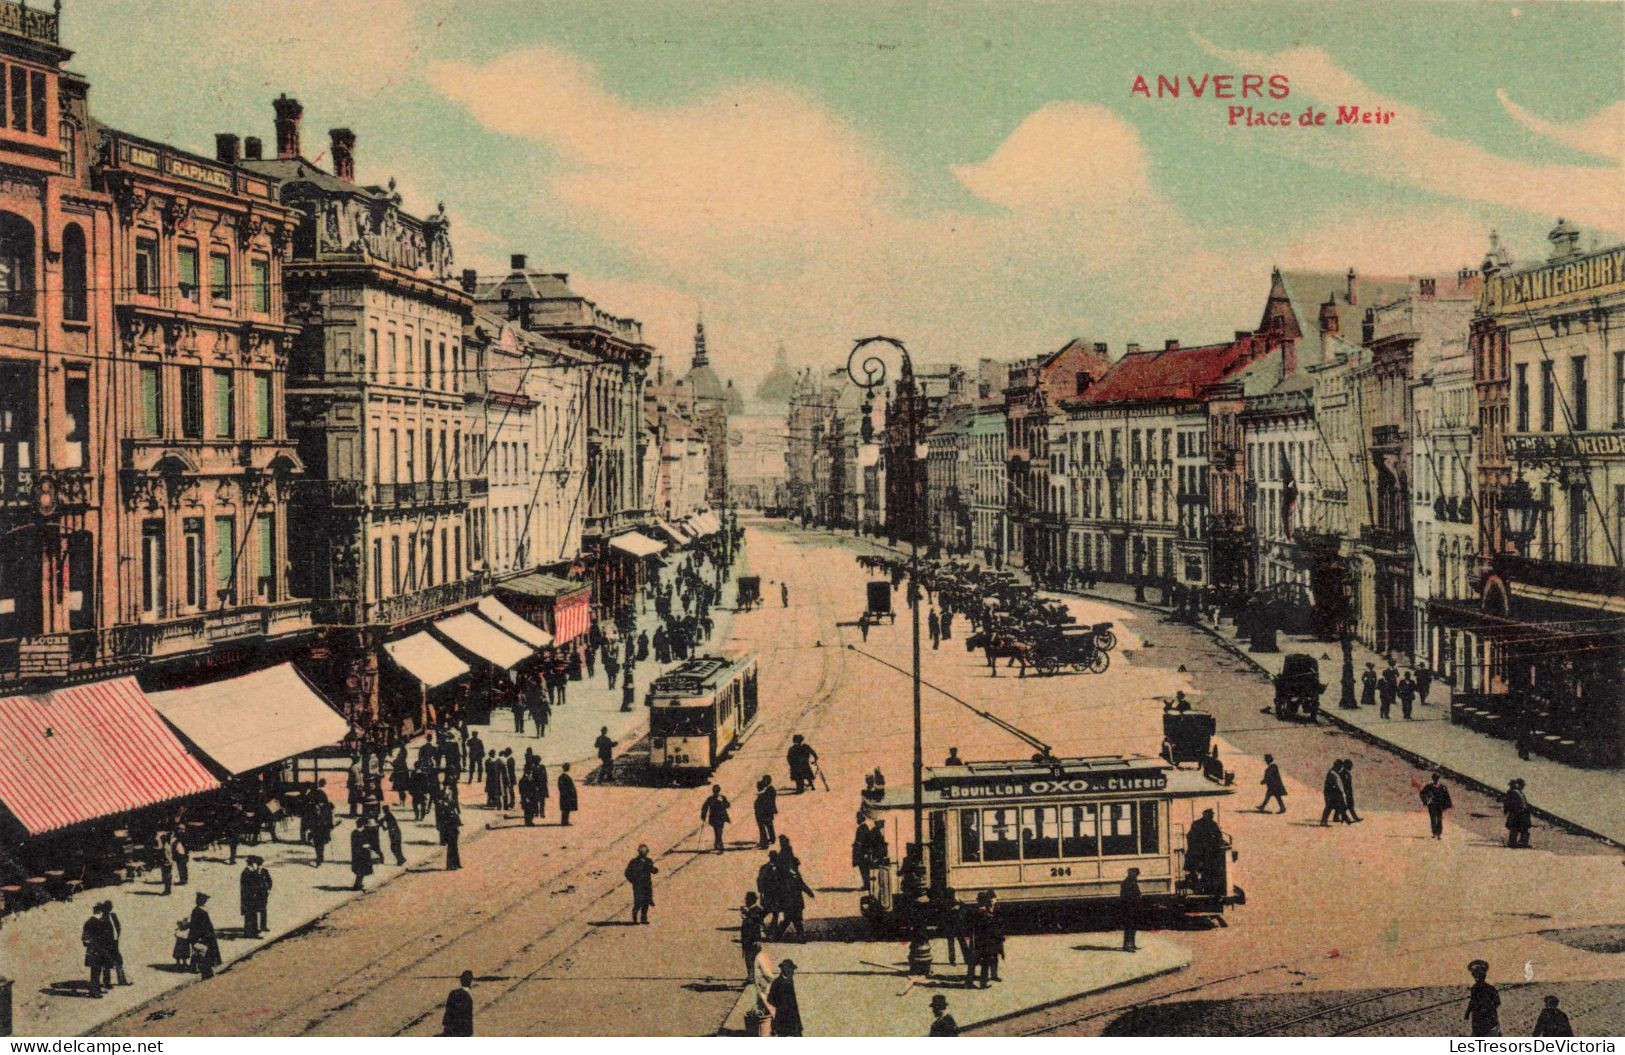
[644,653,757,782]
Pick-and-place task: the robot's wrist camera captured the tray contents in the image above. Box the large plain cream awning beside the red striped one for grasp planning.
[148,663,349,774]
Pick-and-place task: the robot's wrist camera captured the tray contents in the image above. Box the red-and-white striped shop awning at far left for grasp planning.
[0,678,219,836]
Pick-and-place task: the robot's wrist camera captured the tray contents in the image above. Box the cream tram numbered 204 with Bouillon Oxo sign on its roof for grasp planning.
[861,754,1246,925]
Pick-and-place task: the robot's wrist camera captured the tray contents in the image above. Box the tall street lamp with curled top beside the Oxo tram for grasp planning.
[847,336,931,975]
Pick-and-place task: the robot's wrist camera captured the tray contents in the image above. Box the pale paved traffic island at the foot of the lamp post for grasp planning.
[720,930,1191,1037]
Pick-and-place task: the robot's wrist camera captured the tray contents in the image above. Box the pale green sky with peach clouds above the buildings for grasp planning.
[62,0,1625,392]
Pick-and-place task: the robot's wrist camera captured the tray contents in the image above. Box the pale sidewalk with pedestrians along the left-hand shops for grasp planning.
[0,539,748,1037]
